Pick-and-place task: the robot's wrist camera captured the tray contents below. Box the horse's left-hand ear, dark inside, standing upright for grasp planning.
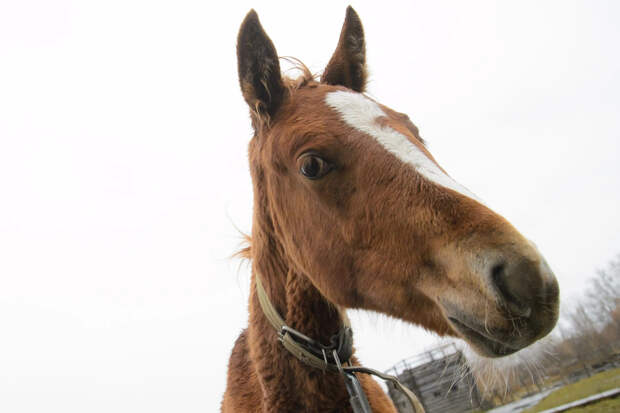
[237,10,284,117]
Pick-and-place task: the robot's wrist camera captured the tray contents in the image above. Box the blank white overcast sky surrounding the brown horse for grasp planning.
[0,0,620,412]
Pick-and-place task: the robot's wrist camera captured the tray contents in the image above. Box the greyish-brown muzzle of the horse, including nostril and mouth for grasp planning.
[438,243,559,357]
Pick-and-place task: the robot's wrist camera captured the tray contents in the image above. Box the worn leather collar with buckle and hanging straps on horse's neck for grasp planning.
[256,275,424,413]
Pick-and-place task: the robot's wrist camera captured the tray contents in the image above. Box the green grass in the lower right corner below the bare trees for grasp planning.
[524,368,620,413]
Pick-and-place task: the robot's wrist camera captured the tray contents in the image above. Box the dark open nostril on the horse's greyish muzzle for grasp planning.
[491,262,532,317]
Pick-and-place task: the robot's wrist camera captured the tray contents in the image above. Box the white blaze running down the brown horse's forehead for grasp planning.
[325,90,482,203]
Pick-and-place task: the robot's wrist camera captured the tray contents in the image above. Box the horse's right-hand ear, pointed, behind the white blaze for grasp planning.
[321,6,366,92]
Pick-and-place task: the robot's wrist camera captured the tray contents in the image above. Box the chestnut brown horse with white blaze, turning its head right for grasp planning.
[222,7,559,412]
